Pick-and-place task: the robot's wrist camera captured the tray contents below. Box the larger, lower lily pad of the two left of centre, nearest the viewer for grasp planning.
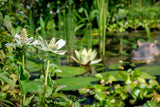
[56,77,98,90]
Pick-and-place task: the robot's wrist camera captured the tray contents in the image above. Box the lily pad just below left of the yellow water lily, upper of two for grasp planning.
[57,66,86,77]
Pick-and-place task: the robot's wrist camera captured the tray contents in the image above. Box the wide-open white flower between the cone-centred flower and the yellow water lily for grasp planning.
[34,36,66,55]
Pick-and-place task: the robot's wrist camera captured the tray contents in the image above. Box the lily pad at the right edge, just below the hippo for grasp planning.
[136,66,160,75]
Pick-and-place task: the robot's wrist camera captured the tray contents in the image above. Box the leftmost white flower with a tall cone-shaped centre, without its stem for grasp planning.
[6,28,38,47]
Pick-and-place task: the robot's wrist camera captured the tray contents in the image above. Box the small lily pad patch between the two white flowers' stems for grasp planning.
[26,60,41,71]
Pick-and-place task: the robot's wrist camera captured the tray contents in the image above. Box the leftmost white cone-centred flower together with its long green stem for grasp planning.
[6,28,38,105]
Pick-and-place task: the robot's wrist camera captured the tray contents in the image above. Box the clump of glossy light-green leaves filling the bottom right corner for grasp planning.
[80,70,160,107]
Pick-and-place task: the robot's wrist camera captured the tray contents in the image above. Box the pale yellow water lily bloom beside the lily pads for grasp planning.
[71,48,101,65]
